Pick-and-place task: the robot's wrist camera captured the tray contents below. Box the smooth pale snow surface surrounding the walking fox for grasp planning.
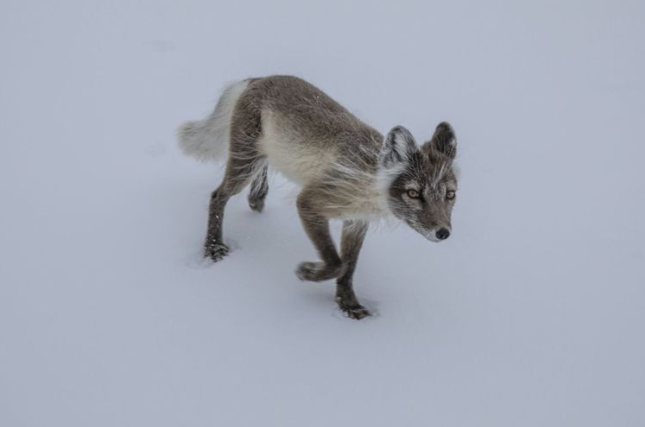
[0,0,645,427]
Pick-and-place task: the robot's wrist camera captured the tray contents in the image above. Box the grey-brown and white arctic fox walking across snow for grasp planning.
[178,76,457,319]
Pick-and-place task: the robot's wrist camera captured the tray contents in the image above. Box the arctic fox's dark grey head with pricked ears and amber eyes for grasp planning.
[379,122,457,242]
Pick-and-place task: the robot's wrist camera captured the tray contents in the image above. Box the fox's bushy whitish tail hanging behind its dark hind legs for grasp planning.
[177,80,248,162]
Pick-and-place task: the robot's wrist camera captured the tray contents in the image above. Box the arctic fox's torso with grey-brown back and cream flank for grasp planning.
[248,76,388,219]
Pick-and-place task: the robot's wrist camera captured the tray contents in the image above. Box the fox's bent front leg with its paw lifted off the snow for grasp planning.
[296,188,345,282]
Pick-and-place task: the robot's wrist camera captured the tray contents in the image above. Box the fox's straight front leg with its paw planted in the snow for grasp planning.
[336,221,370,320]
